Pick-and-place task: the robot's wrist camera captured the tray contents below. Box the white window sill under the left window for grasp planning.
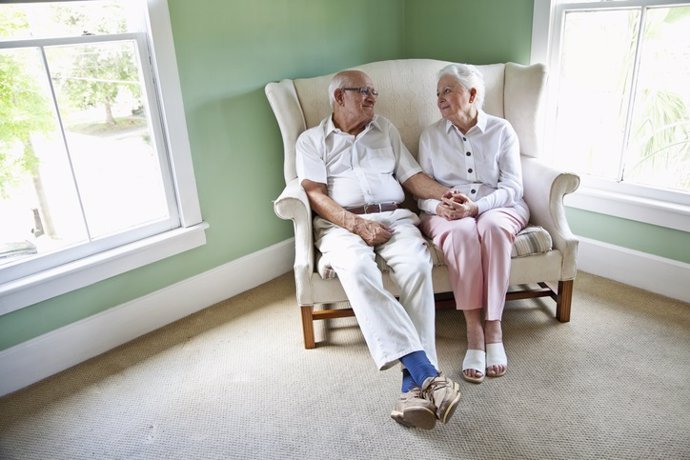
[0,222,208,315]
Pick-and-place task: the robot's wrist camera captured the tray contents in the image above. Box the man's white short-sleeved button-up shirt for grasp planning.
[296,115,422,207]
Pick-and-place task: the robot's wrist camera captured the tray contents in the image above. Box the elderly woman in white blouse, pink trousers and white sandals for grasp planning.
[419,64,529,383]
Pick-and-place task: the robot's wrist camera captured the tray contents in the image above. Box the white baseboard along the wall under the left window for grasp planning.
[0,239,295,396]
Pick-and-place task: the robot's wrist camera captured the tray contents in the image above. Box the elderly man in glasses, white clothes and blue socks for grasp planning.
[296,70,460,429]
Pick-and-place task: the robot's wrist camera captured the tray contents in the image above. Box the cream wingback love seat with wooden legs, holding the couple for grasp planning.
[265,59,580,348]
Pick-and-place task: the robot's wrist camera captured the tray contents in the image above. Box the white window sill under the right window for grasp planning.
[565,186,690,232]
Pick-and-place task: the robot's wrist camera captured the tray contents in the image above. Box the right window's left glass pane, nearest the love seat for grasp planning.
[555,10,640,180]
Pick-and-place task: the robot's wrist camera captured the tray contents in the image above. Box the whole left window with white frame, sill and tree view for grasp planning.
[0,0,206,314]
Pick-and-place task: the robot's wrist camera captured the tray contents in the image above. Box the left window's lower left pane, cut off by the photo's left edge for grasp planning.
[0,48,88,265]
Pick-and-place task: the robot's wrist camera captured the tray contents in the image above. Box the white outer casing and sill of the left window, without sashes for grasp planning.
[0,0,208,315]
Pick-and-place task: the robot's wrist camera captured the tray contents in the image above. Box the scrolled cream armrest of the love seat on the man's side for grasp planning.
[273,178,314,305]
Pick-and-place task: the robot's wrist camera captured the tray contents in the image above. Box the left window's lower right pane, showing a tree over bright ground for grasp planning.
[46,40,169,238]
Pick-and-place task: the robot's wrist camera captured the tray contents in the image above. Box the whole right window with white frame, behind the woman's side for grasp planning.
[532,0,690,231]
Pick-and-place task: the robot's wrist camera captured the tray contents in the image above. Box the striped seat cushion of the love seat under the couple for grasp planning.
[316,225,553,279]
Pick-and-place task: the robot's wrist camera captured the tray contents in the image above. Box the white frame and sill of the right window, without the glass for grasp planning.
[530,0,690,232]
